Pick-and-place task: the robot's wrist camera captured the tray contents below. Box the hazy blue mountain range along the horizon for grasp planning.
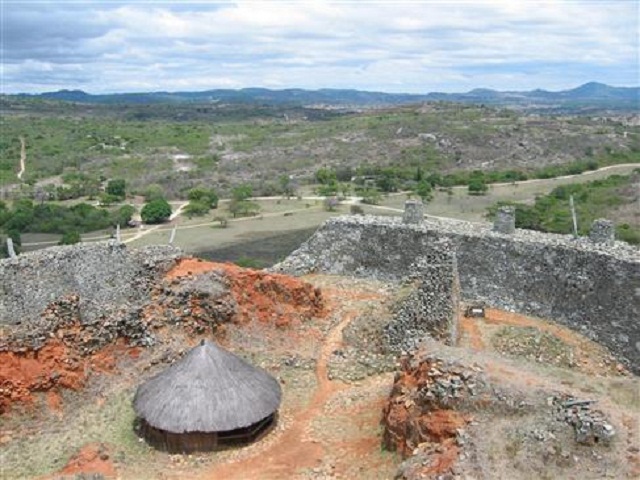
[10,82,640,111]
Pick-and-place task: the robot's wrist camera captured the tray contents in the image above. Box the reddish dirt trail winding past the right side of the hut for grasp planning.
[195,312,355,480]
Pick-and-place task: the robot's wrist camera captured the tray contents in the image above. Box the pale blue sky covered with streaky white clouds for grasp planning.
[0,0,640,94]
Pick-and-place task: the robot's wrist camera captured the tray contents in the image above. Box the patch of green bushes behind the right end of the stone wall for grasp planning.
[488,169,640,244]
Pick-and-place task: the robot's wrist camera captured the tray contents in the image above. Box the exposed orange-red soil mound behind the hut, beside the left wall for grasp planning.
[165,258,325,327]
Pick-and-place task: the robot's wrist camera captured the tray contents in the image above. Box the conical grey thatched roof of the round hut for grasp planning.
[133,341,282,433]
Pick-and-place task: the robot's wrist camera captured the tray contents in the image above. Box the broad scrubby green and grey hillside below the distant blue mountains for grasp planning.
[0,100,640,197]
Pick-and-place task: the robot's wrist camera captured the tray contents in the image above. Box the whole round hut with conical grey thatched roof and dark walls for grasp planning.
[133,340,282,453]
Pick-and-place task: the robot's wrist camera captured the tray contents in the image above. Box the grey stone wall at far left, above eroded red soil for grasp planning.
[0,241,179,325]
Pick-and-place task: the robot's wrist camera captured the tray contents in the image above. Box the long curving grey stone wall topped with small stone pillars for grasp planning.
[274,216,640,372]
